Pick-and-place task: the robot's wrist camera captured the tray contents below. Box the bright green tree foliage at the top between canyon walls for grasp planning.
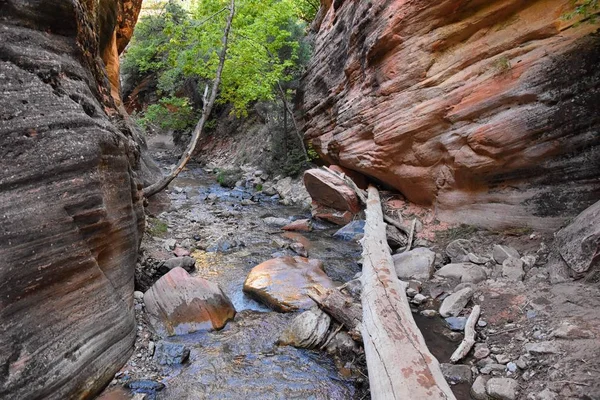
[123,0,319,129]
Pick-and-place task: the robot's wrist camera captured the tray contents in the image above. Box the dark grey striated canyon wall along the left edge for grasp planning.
[0,0,151,399]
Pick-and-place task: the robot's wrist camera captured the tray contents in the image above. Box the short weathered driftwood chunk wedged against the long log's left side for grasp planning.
[308,285,363,341]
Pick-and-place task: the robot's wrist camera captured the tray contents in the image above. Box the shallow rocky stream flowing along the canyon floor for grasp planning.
[100,154,469,400]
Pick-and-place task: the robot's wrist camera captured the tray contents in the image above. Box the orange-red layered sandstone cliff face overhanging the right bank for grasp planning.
[299,0,600,229]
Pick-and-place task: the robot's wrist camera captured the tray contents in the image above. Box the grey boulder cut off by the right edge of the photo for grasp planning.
[555,201,600,278]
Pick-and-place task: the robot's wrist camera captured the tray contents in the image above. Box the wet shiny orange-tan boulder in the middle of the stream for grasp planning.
[244,257,335,312]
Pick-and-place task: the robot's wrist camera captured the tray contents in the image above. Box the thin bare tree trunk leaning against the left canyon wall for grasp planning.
[143,0,235,198]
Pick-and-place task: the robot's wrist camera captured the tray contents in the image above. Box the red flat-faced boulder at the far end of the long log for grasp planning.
[304,168,361,214]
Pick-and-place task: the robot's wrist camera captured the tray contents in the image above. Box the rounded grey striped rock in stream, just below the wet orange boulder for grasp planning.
[278,307,331,349]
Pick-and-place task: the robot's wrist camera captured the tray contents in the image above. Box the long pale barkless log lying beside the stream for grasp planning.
[361,186,455,400]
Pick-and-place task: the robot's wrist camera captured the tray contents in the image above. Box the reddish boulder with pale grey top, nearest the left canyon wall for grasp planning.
[144,268,235,337]
